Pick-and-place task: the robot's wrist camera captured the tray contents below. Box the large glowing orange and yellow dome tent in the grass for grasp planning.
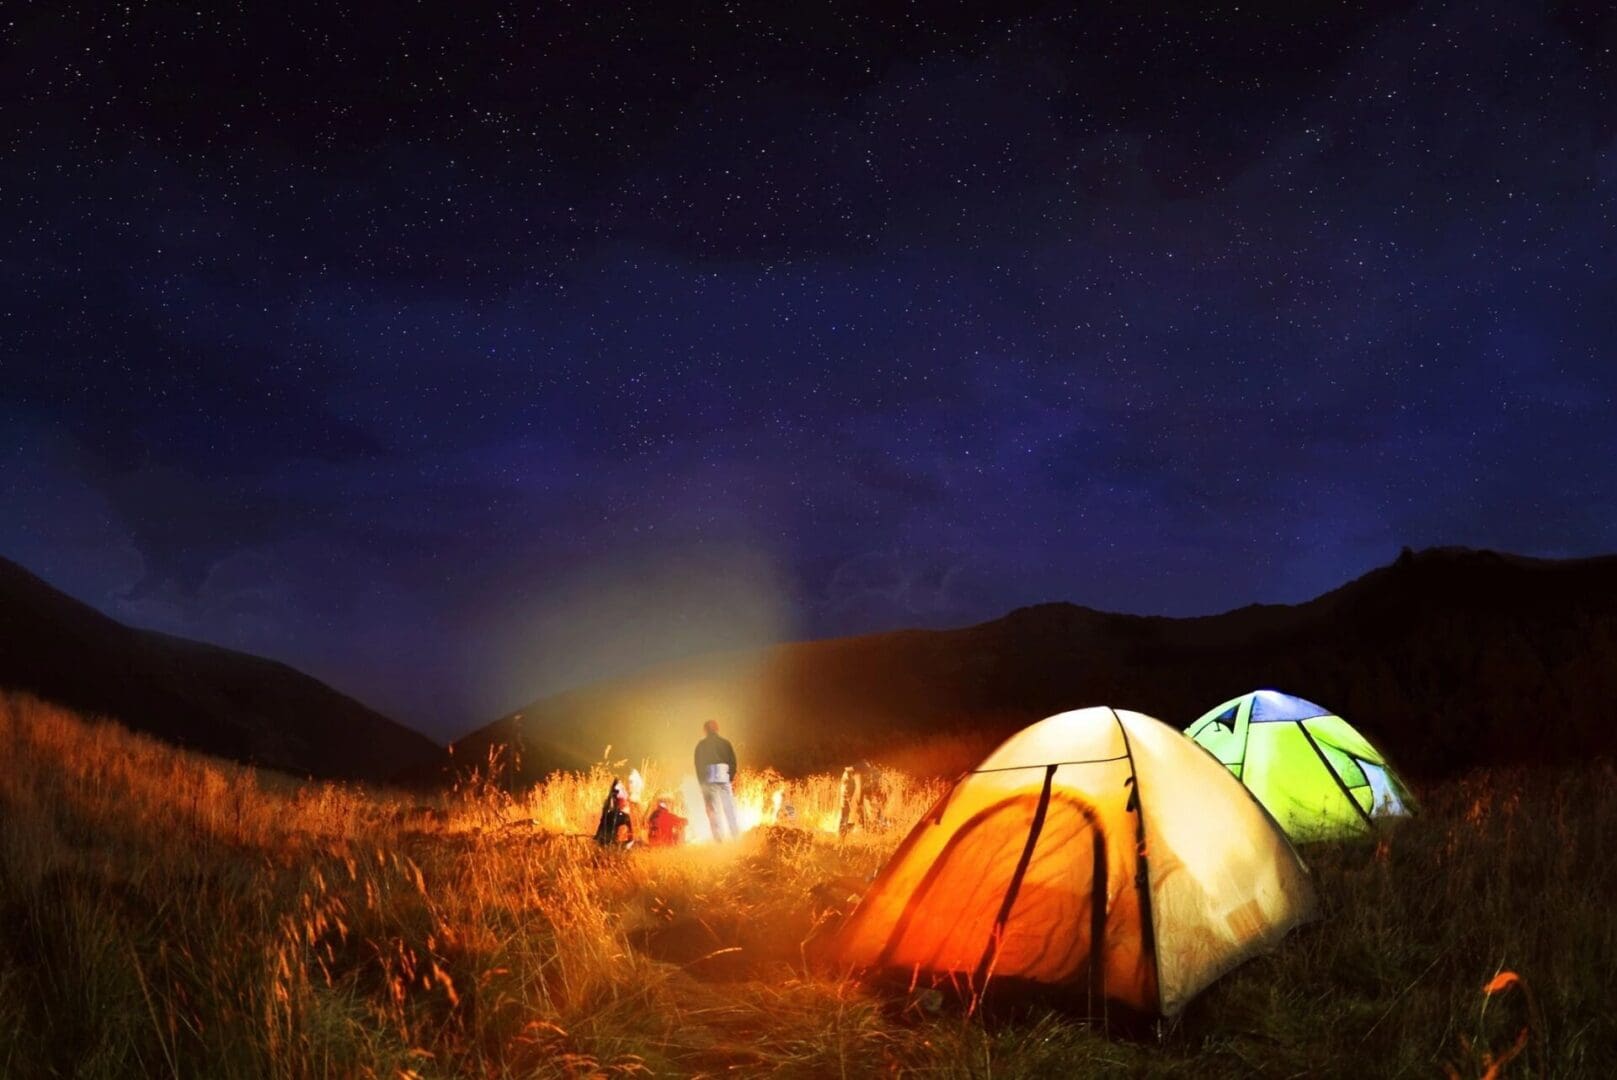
[836,708,1315,1015]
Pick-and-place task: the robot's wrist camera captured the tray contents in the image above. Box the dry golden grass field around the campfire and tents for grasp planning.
[0,697,1617,1080]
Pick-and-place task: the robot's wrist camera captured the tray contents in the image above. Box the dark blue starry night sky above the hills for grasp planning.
[0,0,1617,737]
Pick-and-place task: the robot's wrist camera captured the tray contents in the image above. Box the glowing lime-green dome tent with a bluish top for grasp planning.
[1185,690,1415,841]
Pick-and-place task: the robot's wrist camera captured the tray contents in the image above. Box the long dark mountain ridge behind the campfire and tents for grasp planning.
[453,548,1617,778]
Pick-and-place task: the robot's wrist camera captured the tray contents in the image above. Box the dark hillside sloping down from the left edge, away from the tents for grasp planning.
[0,559,441,779]
